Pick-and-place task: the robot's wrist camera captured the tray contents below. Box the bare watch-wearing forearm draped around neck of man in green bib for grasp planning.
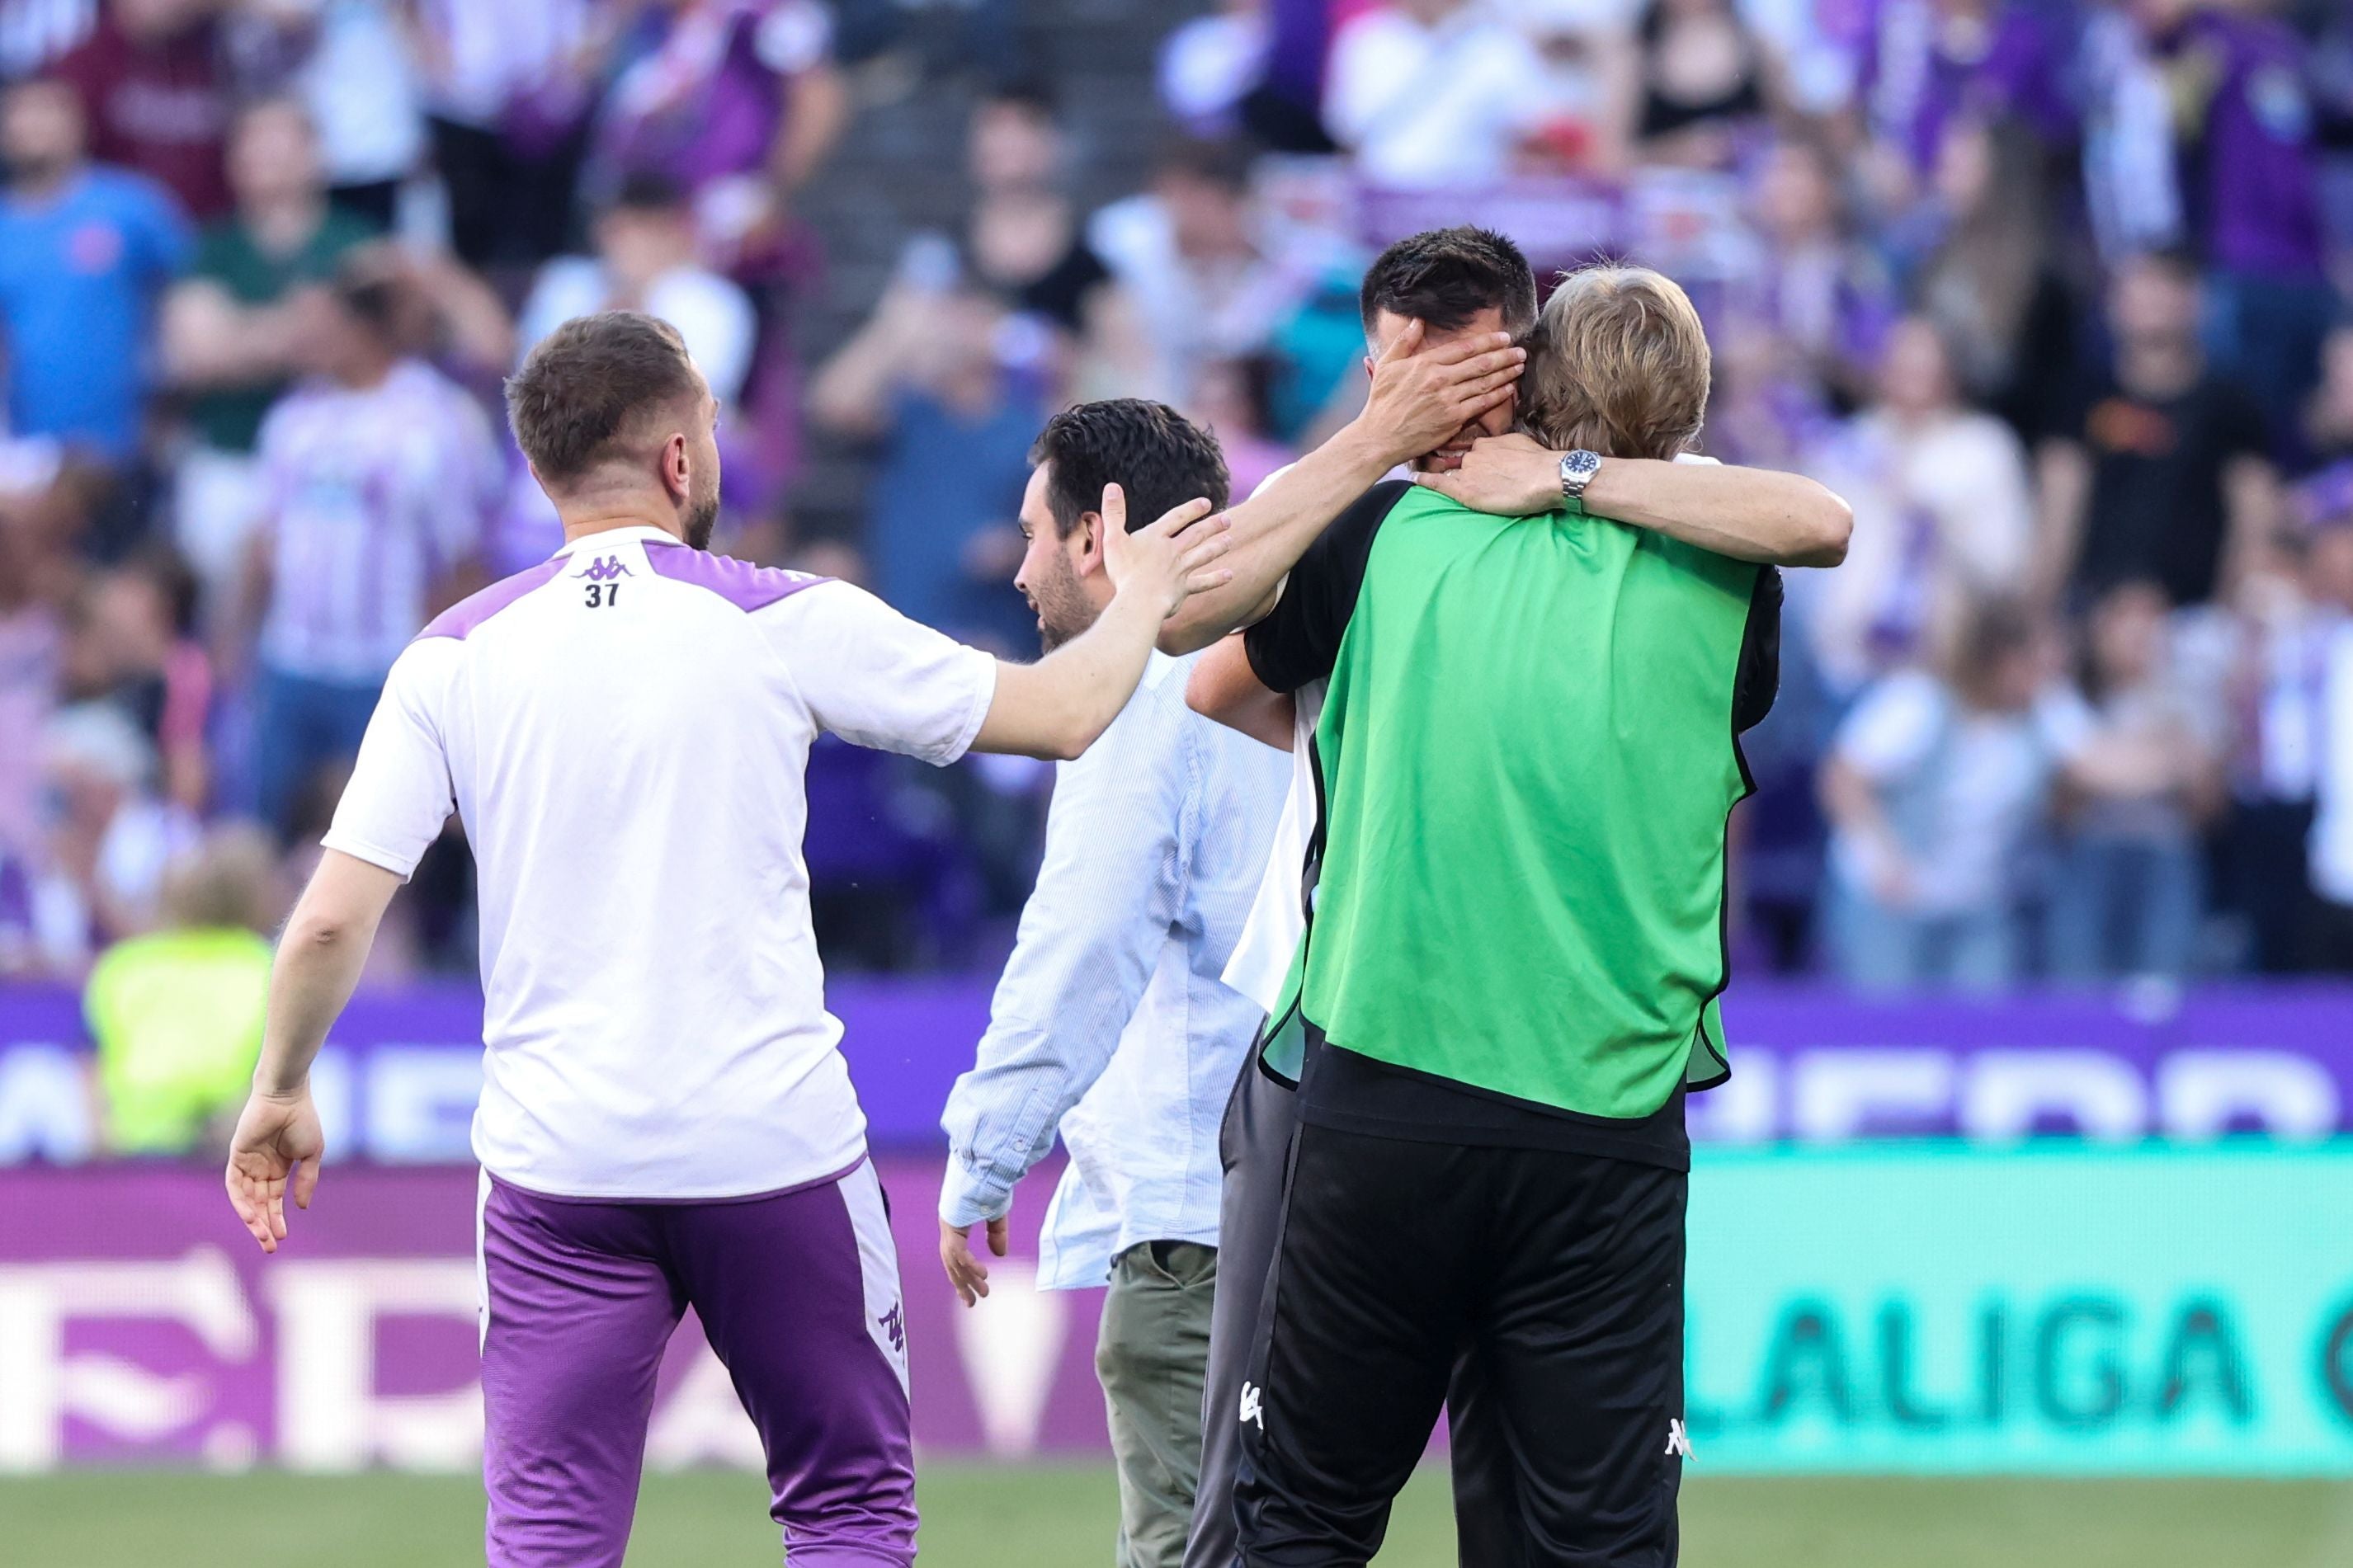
[1414,435,1854,567]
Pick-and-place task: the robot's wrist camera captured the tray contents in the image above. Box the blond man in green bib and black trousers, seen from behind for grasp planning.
[1186,268,1847,1568]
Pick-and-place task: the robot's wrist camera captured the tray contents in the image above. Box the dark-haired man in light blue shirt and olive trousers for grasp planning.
[939,400,1290,1568]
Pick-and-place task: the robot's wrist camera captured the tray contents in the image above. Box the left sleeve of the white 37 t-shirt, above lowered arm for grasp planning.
[320,637,464,877]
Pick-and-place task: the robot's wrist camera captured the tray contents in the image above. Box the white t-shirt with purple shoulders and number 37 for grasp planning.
[325,529,995,1199]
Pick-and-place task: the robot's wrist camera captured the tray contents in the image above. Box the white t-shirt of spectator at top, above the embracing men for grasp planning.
[1325,0,1553,188]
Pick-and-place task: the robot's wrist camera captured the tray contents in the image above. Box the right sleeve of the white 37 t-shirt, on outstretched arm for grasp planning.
[753,583,997,766]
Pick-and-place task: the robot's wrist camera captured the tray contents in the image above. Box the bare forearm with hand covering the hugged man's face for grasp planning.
[1160,322,1527,653]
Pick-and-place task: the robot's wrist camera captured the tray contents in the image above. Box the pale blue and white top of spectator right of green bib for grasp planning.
[1831,670,2091,915]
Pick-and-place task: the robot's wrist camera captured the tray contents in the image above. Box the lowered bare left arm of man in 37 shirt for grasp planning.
[229,849,403,1253]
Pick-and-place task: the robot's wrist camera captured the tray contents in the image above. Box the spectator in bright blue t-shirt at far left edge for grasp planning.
[0,80,196,463]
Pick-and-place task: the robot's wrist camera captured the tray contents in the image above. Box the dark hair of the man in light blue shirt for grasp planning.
[1030,398,1231,536]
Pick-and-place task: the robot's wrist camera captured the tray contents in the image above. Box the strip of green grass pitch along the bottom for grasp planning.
[0,1465,2353,1568]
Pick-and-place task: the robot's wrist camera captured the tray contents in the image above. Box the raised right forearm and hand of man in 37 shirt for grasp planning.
[972,484,1233,761]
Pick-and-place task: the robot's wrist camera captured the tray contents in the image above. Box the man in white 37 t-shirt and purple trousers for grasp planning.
[229,313,1280,1568]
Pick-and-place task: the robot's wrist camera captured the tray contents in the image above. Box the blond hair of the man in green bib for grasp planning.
[1520,266,1710,459]
